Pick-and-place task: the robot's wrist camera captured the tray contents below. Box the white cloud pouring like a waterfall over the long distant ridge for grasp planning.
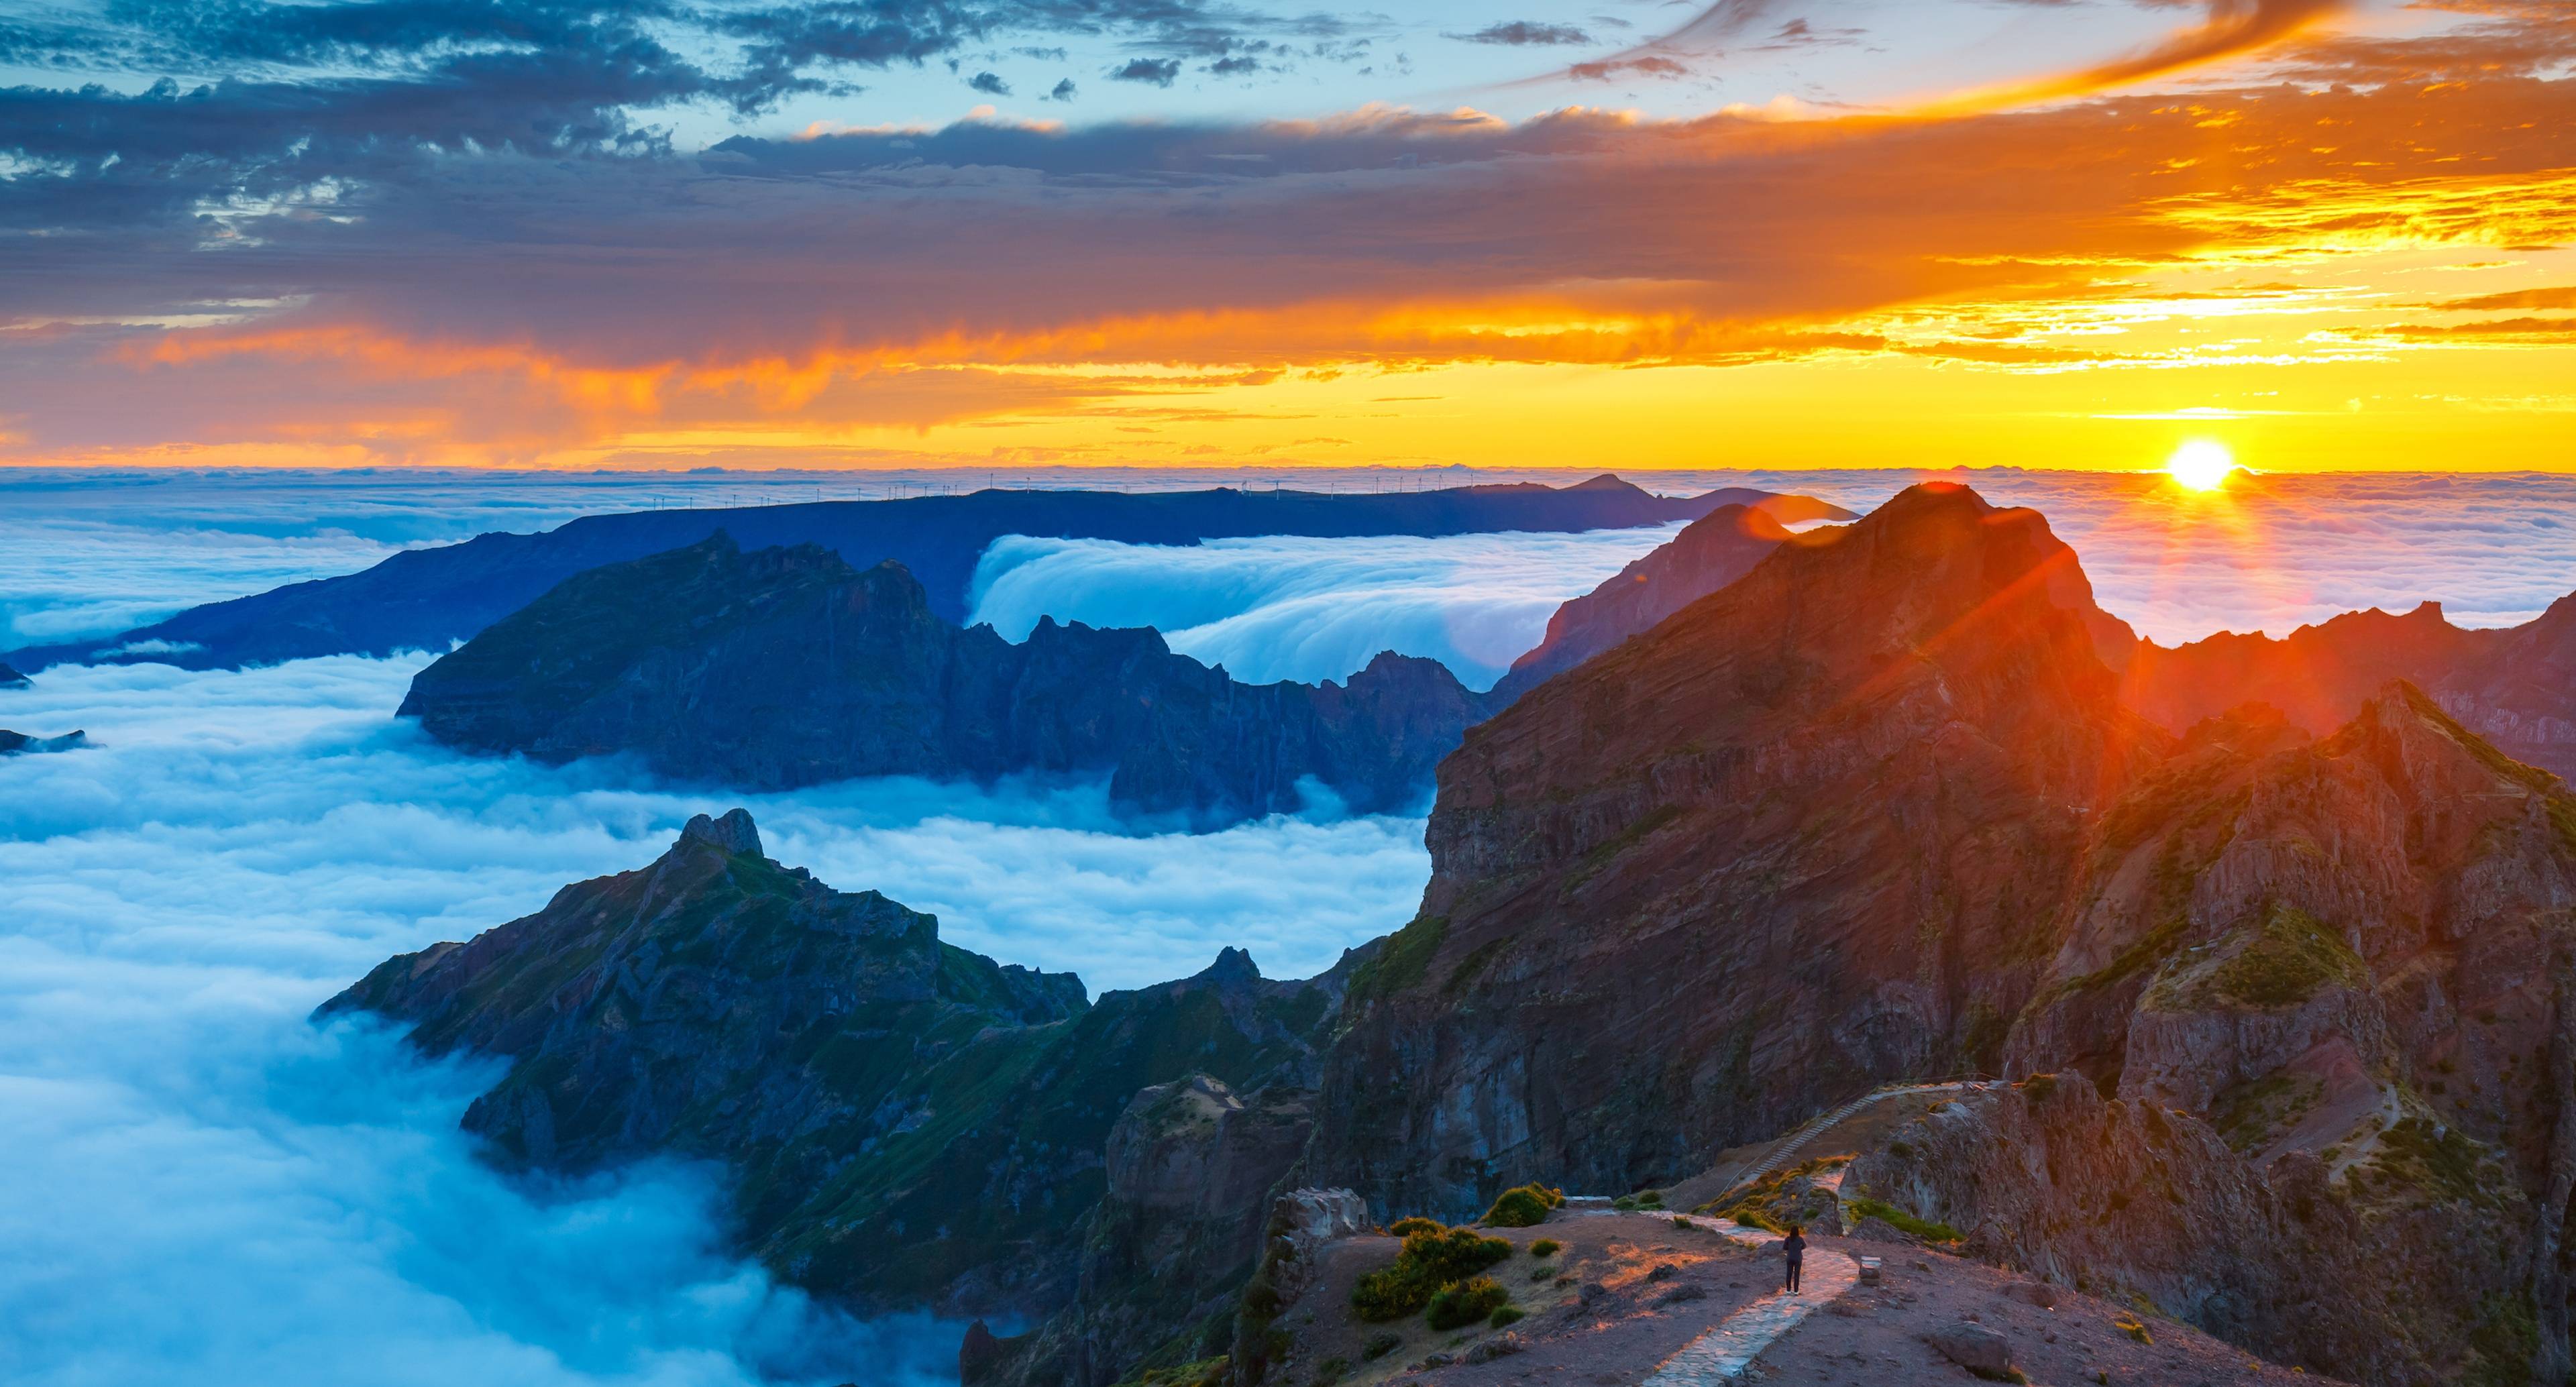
[971,525,1680,689]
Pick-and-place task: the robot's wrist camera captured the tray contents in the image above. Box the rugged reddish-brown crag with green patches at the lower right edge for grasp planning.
[1978,685,2576,1382]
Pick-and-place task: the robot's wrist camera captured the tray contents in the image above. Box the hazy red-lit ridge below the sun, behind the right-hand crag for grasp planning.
[2123,594,2576,777]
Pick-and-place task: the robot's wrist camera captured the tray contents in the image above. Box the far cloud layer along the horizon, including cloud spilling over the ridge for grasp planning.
[25,468,2576,663]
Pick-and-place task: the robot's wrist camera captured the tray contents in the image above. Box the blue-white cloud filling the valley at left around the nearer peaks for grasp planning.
[0,659,1427,1387]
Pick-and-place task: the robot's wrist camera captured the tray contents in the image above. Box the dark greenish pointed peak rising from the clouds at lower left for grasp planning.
[322,811,1342,1315]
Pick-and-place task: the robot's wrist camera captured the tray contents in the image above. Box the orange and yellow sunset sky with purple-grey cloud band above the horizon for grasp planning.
[0,3,2576,471]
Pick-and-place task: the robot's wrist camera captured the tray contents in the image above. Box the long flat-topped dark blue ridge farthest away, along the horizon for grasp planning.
[0,476,1852,669]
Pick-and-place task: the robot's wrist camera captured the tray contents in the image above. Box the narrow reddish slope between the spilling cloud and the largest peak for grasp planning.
[1494,507,1790,708]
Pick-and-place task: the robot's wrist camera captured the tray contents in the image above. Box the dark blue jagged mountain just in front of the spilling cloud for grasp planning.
[402,535,1487,826]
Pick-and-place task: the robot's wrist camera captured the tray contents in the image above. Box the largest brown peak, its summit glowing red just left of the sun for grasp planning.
[1303,486,2161,1217]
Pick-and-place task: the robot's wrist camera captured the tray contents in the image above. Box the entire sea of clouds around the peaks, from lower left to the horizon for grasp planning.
[15,460,2576,1387]
